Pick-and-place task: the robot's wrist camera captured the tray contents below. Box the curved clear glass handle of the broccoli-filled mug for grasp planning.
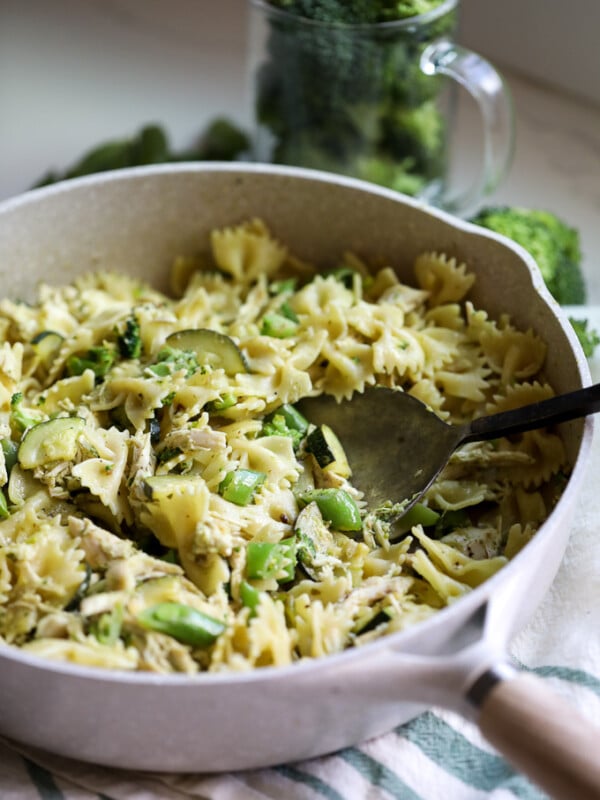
[420,41,515,215]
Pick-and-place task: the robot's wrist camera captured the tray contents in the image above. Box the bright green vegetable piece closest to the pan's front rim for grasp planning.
[137,602,225,647]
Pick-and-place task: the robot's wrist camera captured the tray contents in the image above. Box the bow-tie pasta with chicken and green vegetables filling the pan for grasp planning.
[0,220,567,674]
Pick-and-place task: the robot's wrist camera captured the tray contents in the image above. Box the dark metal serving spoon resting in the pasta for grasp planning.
[298,384,600,513]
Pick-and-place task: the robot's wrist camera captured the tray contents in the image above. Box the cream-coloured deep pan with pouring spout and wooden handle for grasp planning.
[0,164,600,800]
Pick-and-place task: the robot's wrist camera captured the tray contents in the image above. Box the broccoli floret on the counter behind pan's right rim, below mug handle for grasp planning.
[471,206,586,305]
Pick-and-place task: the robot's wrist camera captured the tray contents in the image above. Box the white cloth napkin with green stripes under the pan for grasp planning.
[0,362,600,800]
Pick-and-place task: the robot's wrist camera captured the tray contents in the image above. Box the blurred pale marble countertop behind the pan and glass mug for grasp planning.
[0,0,600,303]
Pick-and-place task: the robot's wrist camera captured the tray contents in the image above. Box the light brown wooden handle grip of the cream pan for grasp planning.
[479,675,600,800]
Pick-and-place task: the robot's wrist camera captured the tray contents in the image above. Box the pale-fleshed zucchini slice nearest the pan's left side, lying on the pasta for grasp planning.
[17,417,85,469]
